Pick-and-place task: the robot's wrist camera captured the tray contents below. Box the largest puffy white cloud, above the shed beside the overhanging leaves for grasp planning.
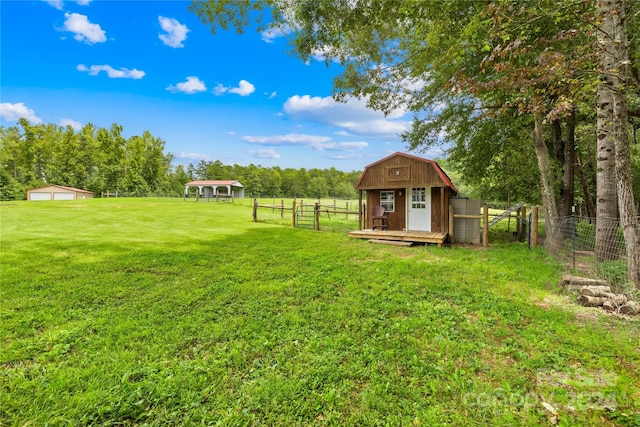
[284,95,411,137]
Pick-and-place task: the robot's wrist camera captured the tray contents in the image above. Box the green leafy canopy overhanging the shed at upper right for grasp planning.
[190,0,640,216]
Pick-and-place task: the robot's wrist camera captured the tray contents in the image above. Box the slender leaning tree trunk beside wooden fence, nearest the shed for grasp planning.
[533,112,562,248]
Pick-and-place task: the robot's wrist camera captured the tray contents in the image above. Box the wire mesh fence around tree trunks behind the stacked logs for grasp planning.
[545,216,627,286]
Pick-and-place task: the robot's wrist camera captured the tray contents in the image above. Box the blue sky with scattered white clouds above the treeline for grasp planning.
[0,0,438,171]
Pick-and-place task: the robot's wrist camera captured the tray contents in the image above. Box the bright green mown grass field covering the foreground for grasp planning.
[0,199,640,426]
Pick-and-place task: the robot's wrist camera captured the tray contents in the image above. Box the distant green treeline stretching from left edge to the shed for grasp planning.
[0,119,360,200]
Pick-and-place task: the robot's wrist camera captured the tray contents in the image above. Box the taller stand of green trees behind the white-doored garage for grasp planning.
[0,119,171,195]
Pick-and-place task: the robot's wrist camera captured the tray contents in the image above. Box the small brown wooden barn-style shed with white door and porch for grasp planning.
[349,152,458,244]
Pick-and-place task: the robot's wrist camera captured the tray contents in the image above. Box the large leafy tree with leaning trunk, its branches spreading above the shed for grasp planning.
[191,0,594,244]
